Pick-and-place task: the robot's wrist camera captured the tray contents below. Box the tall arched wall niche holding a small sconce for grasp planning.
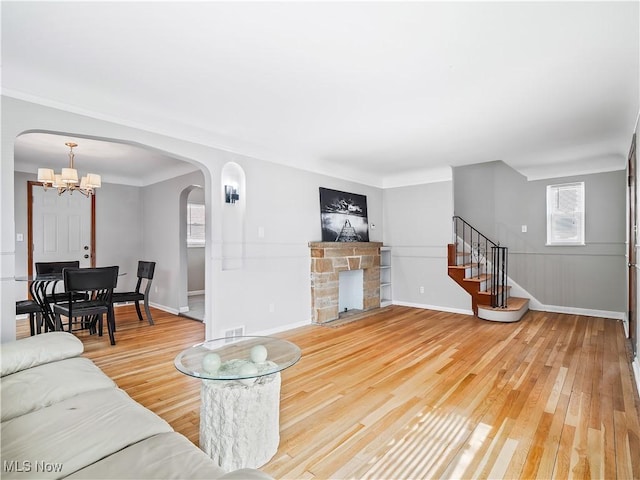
[220,162,247,270]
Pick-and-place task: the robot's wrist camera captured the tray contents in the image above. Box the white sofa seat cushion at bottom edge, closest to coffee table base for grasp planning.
[69,432,225,480]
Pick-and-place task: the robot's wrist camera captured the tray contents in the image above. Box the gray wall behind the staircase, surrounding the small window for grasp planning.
[453,162,626,317]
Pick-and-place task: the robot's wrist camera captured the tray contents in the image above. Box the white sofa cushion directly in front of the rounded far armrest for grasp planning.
[0,357,116,422]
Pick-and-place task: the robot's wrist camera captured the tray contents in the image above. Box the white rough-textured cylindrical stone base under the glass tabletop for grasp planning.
[200,373,280,470]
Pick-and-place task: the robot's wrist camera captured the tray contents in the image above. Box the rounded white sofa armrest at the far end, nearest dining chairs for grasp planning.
[0,332,84,377]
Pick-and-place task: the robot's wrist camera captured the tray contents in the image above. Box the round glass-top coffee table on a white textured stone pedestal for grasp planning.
[174,336,301,470]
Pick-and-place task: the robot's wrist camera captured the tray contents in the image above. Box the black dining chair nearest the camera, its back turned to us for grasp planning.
[53,266,119,345]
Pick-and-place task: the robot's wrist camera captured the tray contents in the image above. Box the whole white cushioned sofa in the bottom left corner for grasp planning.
[0,332,271,479]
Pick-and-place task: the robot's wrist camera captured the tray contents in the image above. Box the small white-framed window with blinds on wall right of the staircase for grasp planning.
[547,182,584,245]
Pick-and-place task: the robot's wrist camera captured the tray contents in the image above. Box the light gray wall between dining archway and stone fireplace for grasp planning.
[212,157,384,338]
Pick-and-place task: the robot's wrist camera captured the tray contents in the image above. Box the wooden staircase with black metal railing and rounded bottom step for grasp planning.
[447,216,529,322]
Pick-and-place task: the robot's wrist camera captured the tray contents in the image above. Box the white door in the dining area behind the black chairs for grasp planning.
[33,186,92,273]
